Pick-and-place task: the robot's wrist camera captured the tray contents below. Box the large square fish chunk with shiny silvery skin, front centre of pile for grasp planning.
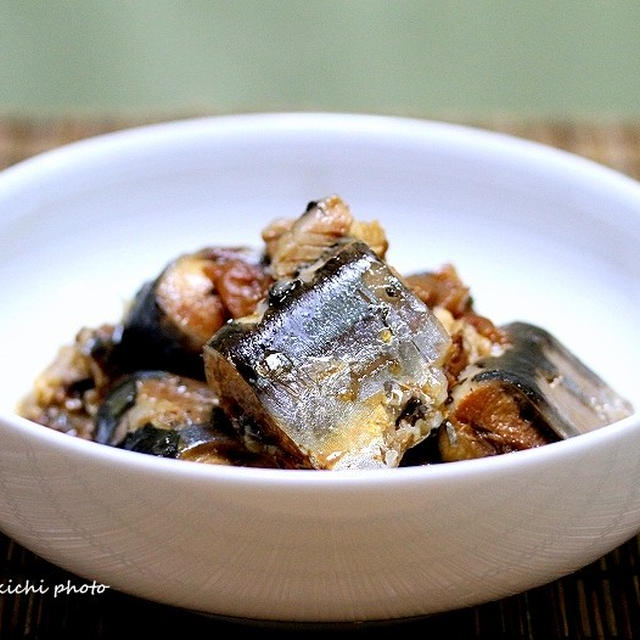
[204,241,450,469]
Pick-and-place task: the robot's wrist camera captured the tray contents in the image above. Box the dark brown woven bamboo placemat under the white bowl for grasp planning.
[0,114,640,640]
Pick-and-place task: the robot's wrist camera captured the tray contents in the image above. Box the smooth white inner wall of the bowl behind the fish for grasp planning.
[0,114,640,420]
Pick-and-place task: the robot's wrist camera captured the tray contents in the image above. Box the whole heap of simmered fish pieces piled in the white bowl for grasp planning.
[19,195,632,470]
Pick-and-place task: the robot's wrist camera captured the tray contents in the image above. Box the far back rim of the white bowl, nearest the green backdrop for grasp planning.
[0,111,640,200]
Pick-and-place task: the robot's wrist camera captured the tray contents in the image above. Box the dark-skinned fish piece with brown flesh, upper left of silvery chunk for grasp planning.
[116,247,270,380]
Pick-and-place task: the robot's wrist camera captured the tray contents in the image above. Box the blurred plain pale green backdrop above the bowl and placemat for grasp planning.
[0,0,640,119]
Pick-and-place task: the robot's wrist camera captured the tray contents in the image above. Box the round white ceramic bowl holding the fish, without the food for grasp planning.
[0,114,640,622]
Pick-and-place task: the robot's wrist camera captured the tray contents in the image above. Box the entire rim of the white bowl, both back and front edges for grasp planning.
[0,111,640,490]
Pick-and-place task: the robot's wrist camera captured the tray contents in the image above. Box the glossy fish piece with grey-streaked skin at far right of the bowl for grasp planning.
[439,322,632,461]
